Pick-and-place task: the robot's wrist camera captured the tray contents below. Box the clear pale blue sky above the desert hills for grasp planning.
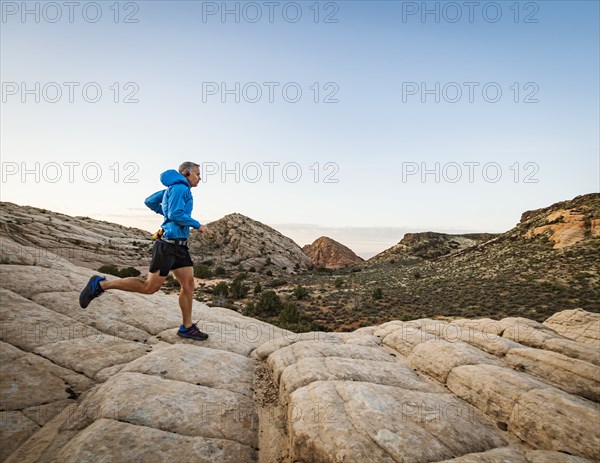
[0,1,600,257]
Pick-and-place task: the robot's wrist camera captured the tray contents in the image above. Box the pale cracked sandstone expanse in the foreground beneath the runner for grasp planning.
[0,230,600,463]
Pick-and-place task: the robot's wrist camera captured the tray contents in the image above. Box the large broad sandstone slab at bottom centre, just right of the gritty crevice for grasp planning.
[290,381,506,463]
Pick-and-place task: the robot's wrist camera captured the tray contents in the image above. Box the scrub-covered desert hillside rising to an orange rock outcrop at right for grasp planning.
[292,193,600,330]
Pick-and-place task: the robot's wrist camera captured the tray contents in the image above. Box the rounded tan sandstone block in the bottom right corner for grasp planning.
[509,388,600,460]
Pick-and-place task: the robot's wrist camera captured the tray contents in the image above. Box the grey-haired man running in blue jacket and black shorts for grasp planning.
[79,162,208,341]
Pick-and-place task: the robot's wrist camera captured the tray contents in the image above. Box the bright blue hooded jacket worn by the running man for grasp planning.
[144,169,200,240]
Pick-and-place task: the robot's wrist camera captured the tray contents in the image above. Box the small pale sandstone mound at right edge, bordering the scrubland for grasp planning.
[544,309,600,348]
